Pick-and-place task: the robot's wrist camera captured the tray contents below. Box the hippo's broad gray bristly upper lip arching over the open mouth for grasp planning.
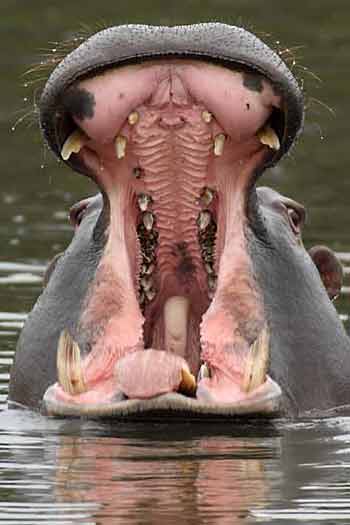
[39,23,304,177]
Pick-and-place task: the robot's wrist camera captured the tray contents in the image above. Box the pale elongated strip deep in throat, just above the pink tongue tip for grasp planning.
[164,295,190,356]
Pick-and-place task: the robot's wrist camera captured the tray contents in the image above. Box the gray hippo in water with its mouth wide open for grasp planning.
[9,23,350,419]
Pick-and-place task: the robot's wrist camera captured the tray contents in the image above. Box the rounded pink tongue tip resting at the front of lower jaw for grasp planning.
[115,349,195,399]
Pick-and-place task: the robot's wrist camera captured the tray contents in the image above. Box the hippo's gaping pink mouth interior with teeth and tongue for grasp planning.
[39,25,304,416]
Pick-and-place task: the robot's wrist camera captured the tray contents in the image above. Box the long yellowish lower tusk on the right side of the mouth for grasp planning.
[242,325,270,392]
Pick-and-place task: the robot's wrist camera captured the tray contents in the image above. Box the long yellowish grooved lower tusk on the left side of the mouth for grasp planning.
[57,330,86,396]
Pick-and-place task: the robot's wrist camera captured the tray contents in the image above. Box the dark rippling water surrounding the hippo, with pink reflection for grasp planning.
[0,0,350,525]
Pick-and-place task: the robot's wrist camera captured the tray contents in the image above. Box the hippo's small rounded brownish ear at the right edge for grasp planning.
[309,246,343,300]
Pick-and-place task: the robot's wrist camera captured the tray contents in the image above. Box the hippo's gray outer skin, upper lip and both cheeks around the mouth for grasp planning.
[9,24,350,414]
